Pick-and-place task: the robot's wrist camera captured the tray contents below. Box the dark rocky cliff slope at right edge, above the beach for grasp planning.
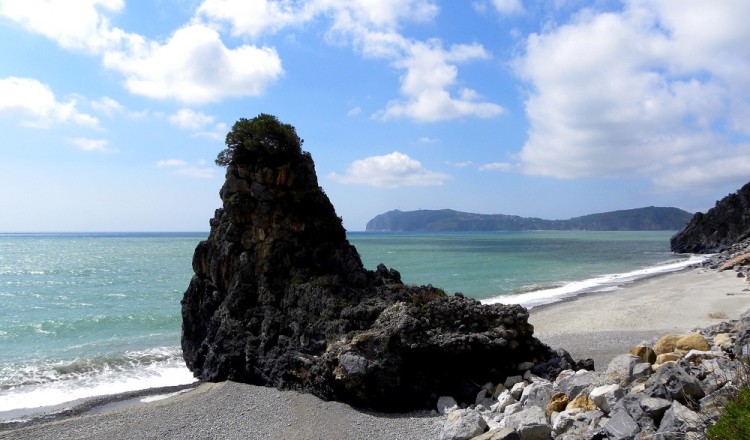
[670,183,750,253]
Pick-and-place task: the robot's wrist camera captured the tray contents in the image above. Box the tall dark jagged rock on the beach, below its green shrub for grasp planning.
[182,118,555,411]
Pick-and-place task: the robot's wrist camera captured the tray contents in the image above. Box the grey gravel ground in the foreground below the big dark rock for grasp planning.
[0,382,443,440]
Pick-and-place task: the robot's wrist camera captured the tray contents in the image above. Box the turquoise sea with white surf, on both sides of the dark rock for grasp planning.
[0,231,702,423]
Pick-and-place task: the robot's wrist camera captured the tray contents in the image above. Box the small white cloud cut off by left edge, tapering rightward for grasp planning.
[0,77,99,128]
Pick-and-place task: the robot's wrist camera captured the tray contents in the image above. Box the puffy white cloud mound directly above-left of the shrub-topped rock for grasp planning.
[104,24,283,103]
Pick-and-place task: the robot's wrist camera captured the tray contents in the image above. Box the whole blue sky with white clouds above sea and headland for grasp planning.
[0,0,750,232]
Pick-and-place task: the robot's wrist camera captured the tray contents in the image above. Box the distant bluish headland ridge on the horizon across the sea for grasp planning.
[366,206,693,232]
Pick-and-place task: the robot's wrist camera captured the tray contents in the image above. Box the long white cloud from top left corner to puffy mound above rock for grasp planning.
[0,0,283,103]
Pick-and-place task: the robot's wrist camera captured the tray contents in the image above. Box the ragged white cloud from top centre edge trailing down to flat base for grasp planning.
[199,0,503,122]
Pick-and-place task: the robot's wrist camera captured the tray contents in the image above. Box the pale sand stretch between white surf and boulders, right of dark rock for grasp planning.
[529,267,750,371]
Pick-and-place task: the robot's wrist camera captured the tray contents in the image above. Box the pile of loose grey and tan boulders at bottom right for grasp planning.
[437,311,750,440]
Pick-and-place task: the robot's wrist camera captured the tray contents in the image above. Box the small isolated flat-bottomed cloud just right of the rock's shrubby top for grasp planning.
[328,151,450,188]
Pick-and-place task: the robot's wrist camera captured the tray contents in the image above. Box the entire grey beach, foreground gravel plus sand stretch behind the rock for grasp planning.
[5,269,750,440]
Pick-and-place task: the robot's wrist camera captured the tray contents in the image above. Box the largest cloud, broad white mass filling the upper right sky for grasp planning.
[515,0,750,188]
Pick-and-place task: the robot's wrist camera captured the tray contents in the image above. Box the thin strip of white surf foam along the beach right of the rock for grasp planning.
[482,255,711,308]
